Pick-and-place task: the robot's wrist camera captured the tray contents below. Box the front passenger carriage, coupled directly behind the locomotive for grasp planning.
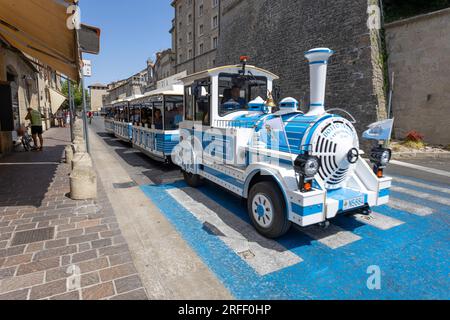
[130,85,183,162]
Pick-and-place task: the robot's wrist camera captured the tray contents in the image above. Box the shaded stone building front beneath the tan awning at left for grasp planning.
[0,40,65,156]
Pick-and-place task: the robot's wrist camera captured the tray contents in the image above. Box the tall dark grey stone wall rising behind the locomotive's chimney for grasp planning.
[217,0,386,138]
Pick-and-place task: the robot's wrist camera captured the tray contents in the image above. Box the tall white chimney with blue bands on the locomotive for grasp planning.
[305,48,334,116]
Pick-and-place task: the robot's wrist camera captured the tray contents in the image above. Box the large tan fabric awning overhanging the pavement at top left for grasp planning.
[0,0,80,82]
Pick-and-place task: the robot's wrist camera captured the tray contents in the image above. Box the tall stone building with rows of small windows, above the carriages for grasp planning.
[170,0,221,74]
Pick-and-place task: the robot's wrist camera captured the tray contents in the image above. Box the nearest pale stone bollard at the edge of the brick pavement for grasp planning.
[70,165,97,200]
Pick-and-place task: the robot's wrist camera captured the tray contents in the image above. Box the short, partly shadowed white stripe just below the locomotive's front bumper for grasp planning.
[298,225,362,250]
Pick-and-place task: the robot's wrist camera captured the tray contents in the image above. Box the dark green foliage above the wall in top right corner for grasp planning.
[383,0,450,22]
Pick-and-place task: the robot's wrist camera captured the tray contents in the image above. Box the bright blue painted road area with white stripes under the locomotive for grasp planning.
[142,177,450,299]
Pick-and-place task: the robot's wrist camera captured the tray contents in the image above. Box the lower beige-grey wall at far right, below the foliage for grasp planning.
[386,9,450,145]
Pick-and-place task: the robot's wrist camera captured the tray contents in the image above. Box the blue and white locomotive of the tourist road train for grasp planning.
[173,48,391,238]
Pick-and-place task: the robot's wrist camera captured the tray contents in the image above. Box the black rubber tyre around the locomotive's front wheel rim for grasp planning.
[247,181,292,239]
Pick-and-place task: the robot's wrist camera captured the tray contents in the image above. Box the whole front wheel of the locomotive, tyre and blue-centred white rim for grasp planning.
[247,182,291,239]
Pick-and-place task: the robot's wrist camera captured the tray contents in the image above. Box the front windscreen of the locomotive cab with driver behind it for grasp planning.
[219,73,267,117]
